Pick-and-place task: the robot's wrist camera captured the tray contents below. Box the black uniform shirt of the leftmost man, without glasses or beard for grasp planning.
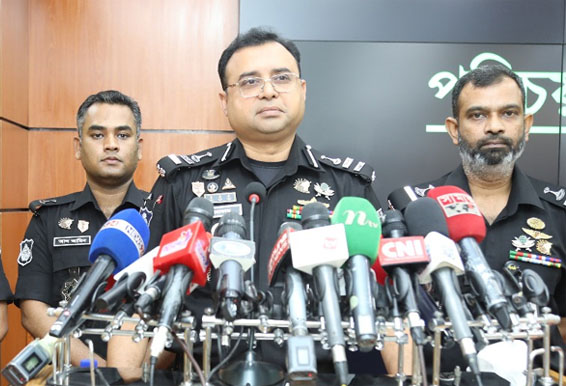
[15,183,147,307]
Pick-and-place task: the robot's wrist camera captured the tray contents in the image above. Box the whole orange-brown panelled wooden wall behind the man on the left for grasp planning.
[0,0,239,376]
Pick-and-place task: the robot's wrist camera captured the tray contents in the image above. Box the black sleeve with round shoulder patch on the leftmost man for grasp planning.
[15,215,53,306]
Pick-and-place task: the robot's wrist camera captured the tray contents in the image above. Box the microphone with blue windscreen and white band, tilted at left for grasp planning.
[49,209,149,338]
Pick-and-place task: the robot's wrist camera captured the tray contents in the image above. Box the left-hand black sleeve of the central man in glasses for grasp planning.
[142,177,192,250]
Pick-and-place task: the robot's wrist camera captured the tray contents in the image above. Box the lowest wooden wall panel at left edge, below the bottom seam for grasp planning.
[0,212,31,385]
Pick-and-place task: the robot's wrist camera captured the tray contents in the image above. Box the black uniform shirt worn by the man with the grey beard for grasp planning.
[415,165,566,371]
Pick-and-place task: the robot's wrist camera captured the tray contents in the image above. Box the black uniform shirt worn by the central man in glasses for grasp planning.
[142,136,379,370]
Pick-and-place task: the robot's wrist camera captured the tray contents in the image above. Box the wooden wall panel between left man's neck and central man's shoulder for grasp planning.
[134,132,234,190]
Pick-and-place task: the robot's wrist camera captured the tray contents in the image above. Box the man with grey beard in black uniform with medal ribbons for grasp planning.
[415,64,566,371]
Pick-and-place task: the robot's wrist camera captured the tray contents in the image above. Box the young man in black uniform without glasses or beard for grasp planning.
[15,91,147,366]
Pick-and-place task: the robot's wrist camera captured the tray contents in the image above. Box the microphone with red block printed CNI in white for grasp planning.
[379,209,430,346]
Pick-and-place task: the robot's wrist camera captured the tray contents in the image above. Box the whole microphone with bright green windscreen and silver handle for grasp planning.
[331,197,381,352]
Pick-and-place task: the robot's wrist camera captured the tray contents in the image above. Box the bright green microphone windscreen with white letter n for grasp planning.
[332,197,381,264]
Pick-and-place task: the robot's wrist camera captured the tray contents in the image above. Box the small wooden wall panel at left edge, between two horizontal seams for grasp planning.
[0,122,29,209]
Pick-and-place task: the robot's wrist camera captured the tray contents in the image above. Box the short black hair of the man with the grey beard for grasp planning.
[452,63,525,119]
